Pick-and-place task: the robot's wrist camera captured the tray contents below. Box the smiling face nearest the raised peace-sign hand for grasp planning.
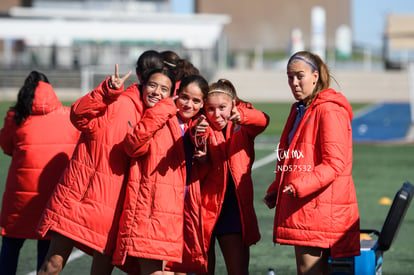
[142,73,172,108]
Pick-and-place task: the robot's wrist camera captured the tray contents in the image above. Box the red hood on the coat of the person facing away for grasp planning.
[32,81,62,115]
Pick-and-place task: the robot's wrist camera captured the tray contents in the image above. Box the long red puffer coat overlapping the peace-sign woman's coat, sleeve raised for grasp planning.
[113,98,186,270]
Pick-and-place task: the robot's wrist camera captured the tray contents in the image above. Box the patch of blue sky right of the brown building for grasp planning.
[351,0,414,48]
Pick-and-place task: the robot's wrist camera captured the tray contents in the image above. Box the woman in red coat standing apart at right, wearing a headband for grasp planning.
[265,51,360,274]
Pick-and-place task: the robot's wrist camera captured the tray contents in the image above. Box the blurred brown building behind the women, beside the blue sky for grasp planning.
[197,0,351,51]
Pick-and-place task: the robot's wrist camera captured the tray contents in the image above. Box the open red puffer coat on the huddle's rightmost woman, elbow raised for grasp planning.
[200,103,269,248]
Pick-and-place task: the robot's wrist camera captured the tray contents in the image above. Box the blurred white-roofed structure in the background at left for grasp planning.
[0,0,230,90]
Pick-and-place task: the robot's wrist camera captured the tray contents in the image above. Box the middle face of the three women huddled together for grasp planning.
[176,82,204,122]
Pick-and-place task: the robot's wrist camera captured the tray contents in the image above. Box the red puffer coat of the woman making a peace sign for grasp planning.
[39,80,143,254]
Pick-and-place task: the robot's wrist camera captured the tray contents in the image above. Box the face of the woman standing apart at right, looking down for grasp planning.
[287,60,319,104]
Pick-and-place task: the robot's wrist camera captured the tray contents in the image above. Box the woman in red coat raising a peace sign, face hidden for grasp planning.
[39,51,167,275]
